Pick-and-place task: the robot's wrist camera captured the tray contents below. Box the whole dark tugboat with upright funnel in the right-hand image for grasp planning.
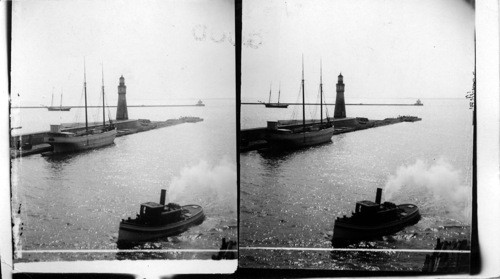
[332,188,420,247]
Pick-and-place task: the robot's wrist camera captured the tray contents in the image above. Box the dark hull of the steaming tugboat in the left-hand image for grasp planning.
[118,205,205,243]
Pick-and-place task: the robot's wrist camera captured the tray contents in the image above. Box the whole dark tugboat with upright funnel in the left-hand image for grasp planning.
[118,189,205,243]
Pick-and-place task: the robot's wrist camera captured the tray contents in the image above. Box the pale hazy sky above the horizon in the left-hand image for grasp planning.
[11,0,235,106]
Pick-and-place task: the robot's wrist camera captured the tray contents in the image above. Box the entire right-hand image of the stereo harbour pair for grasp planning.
[239,0,475,273]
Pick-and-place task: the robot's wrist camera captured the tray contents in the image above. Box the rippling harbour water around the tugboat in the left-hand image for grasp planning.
[12,100,237,261]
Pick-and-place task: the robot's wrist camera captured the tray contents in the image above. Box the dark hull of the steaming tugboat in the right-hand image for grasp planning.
[332,204,420,246]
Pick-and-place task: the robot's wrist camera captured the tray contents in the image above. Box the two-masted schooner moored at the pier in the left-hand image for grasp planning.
[44,64,116,153]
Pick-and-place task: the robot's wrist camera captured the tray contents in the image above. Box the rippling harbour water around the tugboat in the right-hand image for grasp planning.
[239,100,472,271]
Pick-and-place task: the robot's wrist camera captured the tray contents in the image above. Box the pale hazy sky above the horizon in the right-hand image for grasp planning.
[241,0,474,102]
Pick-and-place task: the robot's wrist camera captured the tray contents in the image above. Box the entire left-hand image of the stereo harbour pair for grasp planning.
[10,0,238,263]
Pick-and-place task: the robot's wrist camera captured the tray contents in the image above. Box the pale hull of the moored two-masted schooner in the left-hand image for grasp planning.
[45,129,116,153]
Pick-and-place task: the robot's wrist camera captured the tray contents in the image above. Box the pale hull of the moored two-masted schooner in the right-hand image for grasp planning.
[266,127,334,149]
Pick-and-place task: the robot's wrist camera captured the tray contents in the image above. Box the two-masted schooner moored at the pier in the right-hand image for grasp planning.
[266,58,334,149]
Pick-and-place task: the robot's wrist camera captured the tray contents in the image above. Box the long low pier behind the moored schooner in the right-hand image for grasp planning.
[239,116,422,152]
